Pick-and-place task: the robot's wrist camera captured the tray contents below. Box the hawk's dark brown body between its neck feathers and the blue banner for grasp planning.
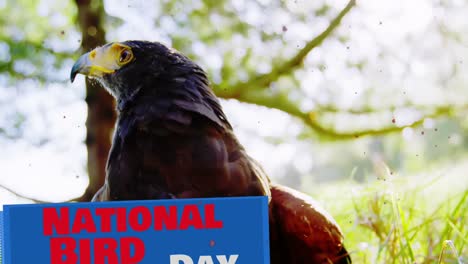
[103,93,269,200]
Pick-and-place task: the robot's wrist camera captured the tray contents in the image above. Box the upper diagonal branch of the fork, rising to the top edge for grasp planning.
[218,0,356,98]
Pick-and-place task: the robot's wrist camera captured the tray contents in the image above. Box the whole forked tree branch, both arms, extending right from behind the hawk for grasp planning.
[213,0,455,140]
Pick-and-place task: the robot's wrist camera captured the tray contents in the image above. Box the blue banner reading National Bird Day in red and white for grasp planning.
[0,197,270,264]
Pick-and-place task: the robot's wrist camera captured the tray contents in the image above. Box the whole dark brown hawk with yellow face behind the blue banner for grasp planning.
[70,41,351,264]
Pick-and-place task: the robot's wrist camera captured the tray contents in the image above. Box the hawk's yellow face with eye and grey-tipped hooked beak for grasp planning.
[70,43,134,82]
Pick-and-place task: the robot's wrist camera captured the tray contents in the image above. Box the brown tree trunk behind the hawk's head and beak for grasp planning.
[75,0,116,201]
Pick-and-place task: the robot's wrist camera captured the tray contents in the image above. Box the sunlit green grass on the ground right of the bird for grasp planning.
[309,162,468,264]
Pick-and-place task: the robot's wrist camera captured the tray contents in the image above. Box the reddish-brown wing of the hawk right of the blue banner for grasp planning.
[270,184,351,264]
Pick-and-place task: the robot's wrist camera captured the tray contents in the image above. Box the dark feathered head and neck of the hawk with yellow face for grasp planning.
[70,40,230,127]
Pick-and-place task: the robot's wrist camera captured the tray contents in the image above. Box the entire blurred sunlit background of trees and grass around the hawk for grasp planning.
[0,0,468,263]
